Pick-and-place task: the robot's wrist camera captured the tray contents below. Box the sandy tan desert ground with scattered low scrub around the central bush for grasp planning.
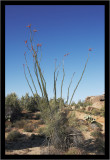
[5,95,105,155]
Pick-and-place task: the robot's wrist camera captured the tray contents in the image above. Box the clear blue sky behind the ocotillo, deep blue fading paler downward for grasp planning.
[5,5,105,102]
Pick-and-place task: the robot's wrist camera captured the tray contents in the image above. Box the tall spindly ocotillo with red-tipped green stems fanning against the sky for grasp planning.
[23,25,89,119]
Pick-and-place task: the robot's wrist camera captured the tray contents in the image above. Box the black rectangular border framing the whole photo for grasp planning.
[1,1,109,159]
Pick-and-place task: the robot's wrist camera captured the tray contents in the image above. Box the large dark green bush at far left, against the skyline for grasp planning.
[5,93,22,121]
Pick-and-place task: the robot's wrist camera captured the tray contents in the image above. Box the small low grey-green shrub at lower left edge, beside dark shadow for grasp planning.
[7,131,22,141]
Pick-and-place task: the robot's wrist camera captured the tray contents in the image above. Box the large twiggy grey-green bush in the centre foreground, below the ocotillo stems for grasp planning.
[44,110,84,150]
